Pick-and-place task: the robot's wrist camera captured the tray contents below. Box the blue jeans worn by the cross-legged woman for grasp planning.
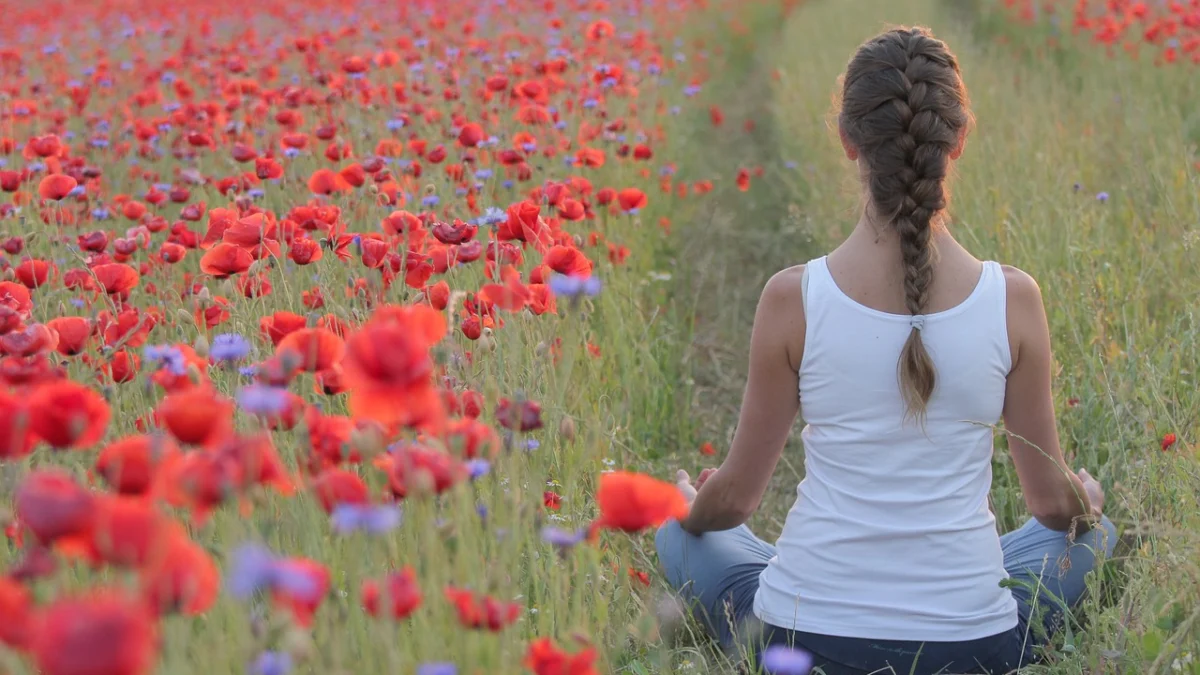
[654,518,1117,675]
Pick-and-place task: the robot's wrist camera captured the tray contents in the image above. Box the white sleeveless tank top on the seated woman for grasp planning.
[754,258,1016,641]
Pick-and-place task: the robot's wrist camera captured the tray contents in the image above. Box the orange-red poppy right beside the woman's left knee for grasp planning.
[596,471,689,532]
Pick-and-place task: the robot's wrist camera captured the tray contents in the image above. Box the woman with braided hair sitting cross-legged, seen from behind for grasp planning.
[656,29,1116,675]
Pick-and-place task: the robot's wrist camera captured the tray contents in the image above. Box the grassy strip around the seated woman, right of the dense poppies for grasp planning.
[664,0,1200,673]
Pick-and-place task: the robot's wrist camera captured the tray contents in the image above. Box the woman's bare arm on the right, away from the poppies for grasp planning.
[1003,267,1099,536]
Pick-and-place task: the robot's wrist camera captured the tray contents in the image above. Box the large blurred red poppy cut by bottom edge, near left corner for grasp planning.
[29,590,157,675]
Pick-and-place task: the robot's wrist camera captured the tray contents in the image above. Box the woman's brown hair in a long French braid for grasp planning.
[838,28,971,420]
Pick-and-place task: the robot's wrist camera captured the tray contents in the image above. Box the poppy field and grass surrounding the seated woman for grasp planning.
[0,0,1200,675]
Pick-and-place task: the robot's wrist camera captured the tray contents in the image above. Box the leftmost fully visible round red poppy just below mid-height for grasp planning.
[29,380,112,449]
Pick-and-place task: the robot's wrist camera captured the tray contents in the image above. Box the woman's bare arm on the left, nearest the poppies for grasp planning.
[680,265,805,534]
